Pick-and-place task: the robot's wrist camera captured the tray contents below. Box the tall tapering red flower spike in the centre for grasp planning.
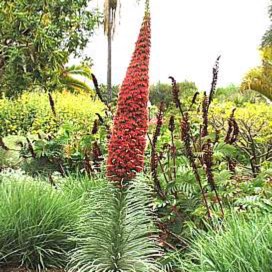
[107,12,151,181]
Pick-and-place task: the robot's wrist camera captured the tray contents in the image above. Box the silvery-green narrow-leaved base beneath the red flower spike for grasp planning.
[69,181,161,272]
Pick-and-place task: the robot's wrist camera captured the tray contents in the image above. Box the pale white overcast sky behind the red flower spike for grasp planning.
[85,0,269,90]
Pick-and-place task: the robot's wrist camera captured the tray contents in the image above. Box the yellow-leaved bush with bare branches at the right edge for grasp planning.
[211,101,272,176]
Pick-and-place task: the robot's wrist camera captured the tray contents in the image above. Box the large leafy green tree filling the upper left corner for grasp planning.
[0,0,100,96]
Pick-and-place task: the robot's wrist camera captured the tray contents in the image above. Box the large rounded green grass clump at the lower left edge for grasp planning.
[0,172,81,270]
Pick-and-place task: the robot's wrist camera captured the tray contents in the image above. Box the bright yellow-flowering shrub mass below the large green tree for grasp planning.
[0,91,104,136]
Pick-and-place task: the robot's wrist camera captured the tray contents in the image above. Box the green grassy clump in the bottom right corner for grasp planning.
[178,215,272,272]
